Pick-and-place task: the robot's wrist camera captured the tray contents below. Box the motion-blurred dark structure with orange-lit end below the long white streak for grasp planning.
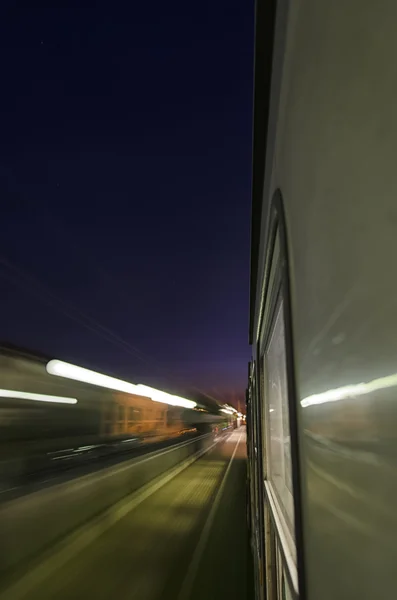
[0,347,186,458]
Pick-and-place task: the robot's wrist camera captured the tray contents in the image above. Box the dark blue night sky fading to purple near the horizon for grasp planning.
[0,0,254,408]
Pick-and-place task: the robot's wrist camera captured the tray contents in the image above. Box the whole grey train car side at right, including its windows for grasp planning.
[247,0,397,600]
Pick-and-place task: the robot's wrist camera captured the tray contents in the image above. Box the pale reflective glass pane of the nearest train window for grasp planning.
[264,301,294,535]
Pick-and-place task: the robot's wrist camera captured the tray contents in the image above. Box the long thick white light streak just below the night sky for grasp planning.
[46,359,196,408]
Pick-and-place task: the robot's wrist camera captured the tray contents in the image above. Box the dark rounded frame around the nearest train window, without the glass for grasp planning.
[256,190,306,600]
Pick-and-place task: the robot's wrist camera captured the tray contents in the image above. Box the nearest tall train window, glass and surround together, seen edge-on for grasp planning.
[256,196,301,600]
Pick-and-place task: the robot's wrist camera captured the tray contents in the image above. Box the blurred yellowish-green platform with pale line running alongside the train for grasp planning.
[2,428,252,600]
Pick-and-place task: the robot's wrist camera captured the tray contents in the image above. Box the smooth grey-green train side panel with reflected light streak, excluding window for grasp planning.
[253,0,397,600]
